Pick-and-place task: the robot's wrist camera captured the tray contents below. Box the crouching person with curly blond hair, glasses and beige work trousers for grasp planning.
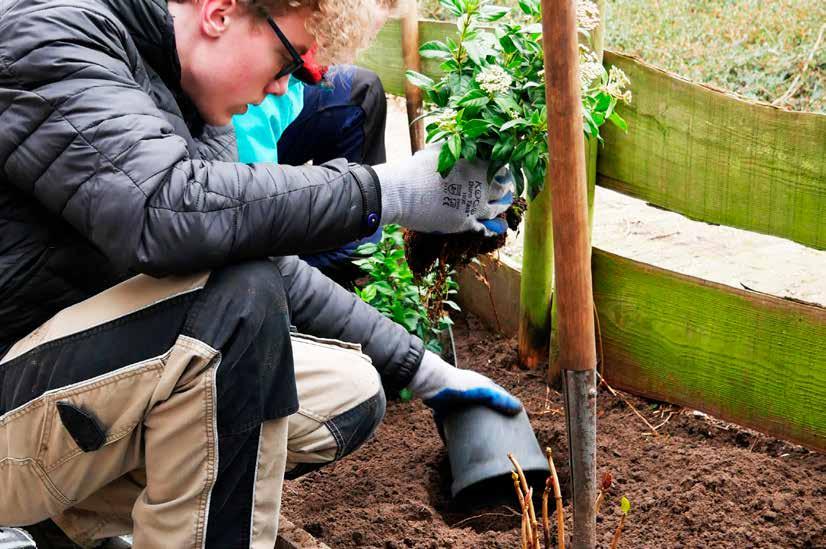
[0,0,519,548]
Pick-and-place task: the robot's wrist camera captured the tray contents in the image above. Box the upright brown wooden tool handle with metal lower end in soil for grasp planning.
[542,0,597,548]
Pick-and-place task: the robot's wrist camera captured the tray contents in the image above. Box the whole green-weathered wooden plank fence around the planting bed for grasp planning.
[359,21,826,451]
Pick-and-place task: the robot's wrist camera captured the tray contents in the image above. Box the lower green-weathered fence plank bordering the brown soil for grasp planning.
[459,255,826,451]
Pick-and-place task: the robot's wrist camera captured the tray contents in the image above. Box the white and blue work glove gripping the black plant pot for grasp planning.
[407,351,522,417]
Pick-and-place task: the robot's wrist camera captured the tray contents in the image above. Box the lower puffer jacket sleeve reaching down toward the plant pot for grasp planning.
[273,256,424,395]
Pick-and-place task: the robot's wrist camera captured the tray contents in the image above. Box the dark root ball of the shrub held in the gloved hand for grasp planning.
[404,198,526,278]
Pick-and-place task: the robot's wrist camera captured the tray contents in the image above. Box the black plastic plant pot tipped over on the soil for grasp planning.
[442,406,549,506]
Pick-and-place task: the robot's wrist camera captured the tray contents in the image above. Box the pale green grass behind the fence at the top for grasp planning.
[419,0,826,112]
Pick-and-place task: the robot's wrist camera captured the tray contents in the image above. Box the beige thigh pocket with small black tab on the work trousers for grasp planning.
[0,357,163,525]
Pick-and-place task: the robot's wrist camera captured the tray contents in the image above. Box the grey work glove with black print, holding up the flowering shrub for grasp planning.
[373,143,513,236]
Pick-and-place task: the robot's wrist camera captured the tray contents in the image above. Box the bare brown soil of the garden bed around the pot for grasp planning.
[282,316,826,548]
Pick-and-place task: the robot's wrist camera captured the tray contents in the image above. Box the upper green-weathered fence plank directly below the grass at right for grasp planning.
[597,52,826,249]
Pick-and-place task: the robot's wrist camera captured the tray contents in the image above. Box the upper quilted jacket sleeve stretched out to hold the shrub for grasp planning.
[0,2,381,275]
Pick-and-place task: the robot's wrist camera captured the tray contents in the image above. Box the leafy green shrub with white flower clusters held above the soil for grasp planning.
[407,0,631,198]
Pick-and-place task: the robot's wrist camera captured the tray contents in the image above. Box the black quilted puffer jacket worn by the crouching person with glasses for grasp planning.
[0,0,422,389]
